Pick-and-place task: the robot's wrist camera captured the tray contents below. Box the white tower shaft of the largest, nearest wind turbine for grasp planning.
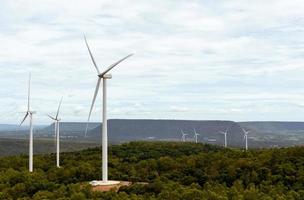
[102,77,108,182]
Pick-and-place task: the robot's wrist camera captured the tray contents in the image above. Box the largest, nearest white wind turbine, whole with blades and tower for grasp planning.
[84,36,133,184]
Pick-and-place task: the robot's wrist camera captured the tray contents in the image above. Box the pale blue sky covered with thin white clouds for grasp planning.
[0,0,304,124]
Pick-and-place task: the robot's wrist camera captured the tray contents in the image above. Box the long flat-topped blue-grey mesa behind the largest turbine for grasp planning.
[88,119,242,145]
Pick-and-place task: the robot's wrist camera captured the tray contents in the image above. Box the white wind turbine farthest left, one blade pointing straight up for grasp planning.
[20,74,36,172]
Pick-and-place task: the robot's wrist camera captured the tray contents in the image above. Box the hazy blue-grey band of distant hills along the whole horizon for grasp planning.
[7,119,304,148]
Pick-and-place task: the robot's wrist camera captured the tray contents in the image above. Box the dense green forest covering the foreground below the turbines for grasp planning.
[0,142,304,200]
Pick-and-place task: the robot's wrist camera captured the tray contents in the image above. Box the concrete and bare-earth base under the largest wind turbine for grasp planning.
[90,180,132,192]
